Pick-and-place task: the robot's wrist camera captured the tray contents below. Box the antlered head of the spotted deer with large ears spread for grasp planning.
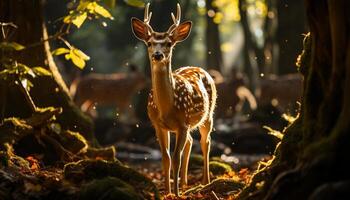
[131,3,192,63]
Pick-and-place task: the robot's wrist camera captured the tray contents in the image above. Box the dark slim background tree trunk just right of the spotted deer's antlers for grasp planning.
[205,0,223,71]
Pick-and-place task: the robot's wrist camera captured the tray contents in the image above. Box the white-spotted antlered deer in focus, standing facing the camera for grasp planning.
[131,3,216,196]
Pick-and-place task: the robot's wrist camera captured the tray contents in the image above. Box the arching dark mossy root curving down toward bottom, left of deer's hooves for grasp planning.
[64,160,160,199]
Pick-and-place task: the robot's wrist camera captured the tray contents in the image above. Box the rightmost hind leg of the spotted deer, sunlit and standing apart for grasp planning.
[199,118,213,184]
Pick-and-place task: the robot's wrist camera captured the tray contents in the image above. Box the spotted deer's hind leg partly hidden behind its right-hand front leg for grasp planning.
[180,134,193,189]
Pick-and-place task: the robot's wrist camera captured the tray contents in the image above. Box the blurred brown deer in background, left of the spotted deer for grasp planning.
[70,65,147,122]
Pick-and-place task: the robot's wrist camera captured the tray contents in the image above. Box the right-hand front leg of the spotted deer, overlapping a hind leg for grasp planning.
[172,129,188,196]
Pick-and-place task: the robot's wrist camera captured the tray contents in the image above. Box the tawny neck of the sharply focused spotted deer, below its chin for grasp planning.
[151,61,174,116]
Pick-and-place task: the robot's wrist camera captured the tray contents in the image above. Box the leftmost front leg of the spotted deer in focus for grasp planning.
[155,126,171,193]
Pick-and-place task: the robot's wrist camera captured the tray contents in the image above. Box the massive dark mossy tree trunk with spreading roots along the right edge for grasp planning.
[239,0,350,200]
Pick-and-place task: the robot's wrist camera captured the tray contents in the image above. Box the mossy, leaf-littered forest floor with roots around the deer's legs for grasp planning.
[0,105,285,200]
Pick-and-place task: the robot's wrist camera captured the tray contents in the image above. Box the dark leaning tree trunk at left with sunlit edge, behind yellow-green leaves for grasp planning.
[0,0,94,141]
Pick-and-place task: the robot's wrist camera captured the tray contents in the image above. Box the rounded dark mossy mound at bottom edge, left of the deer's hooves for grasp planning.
[79,177,142,200]
